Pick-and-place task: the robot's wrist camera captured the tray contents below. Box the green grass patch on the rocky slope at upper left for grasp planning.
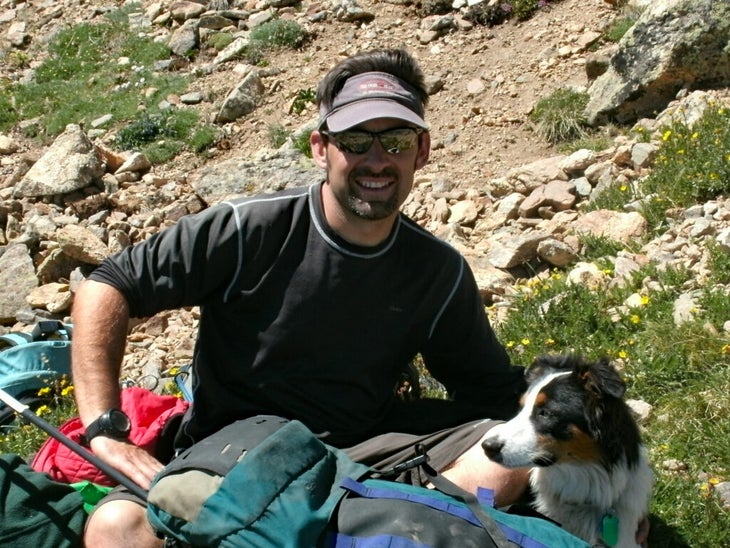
[0,4,217,158]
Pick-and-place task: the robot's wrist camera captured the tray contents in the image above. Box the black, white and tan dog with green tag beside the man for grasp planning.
[482,355,654,548]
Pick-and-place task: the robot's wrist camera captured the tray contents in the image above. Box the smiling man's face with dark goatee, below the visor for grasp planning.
[311,118,430,225]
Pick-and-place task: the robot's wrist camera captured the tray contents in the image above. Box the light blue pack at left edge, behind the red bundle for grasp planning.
[0,320,72,425]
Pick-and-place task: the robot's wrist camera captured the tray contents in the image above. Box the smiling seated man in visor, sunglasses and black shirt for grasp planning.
[73,50,527,548]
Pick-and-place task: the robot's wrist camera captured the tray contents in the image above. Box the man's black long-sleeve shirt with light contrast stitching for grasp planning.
[91,185,524,445]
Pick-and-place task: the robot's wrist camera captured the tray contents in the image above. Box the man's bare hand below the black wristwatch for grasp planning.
[90,436,164,489]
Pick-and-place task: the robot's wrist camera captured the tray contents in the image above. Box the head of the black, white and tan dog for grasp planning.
[482,355,639,468]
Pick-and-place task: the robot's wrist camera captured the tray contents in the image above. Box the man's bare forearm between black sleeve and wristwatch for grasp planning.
[71,280,129,425]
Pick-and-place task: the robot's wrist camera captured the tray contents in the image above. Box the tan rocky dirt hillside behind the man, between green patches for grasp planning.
[0,0,730,384]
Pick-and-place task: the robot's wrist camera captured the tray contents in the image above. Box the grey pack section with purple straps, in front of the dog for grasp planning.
[322,478,590,548]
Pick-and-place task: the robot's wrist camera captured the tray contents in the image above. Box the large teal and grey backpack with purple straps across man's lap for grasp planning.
[147,416,588,548]
